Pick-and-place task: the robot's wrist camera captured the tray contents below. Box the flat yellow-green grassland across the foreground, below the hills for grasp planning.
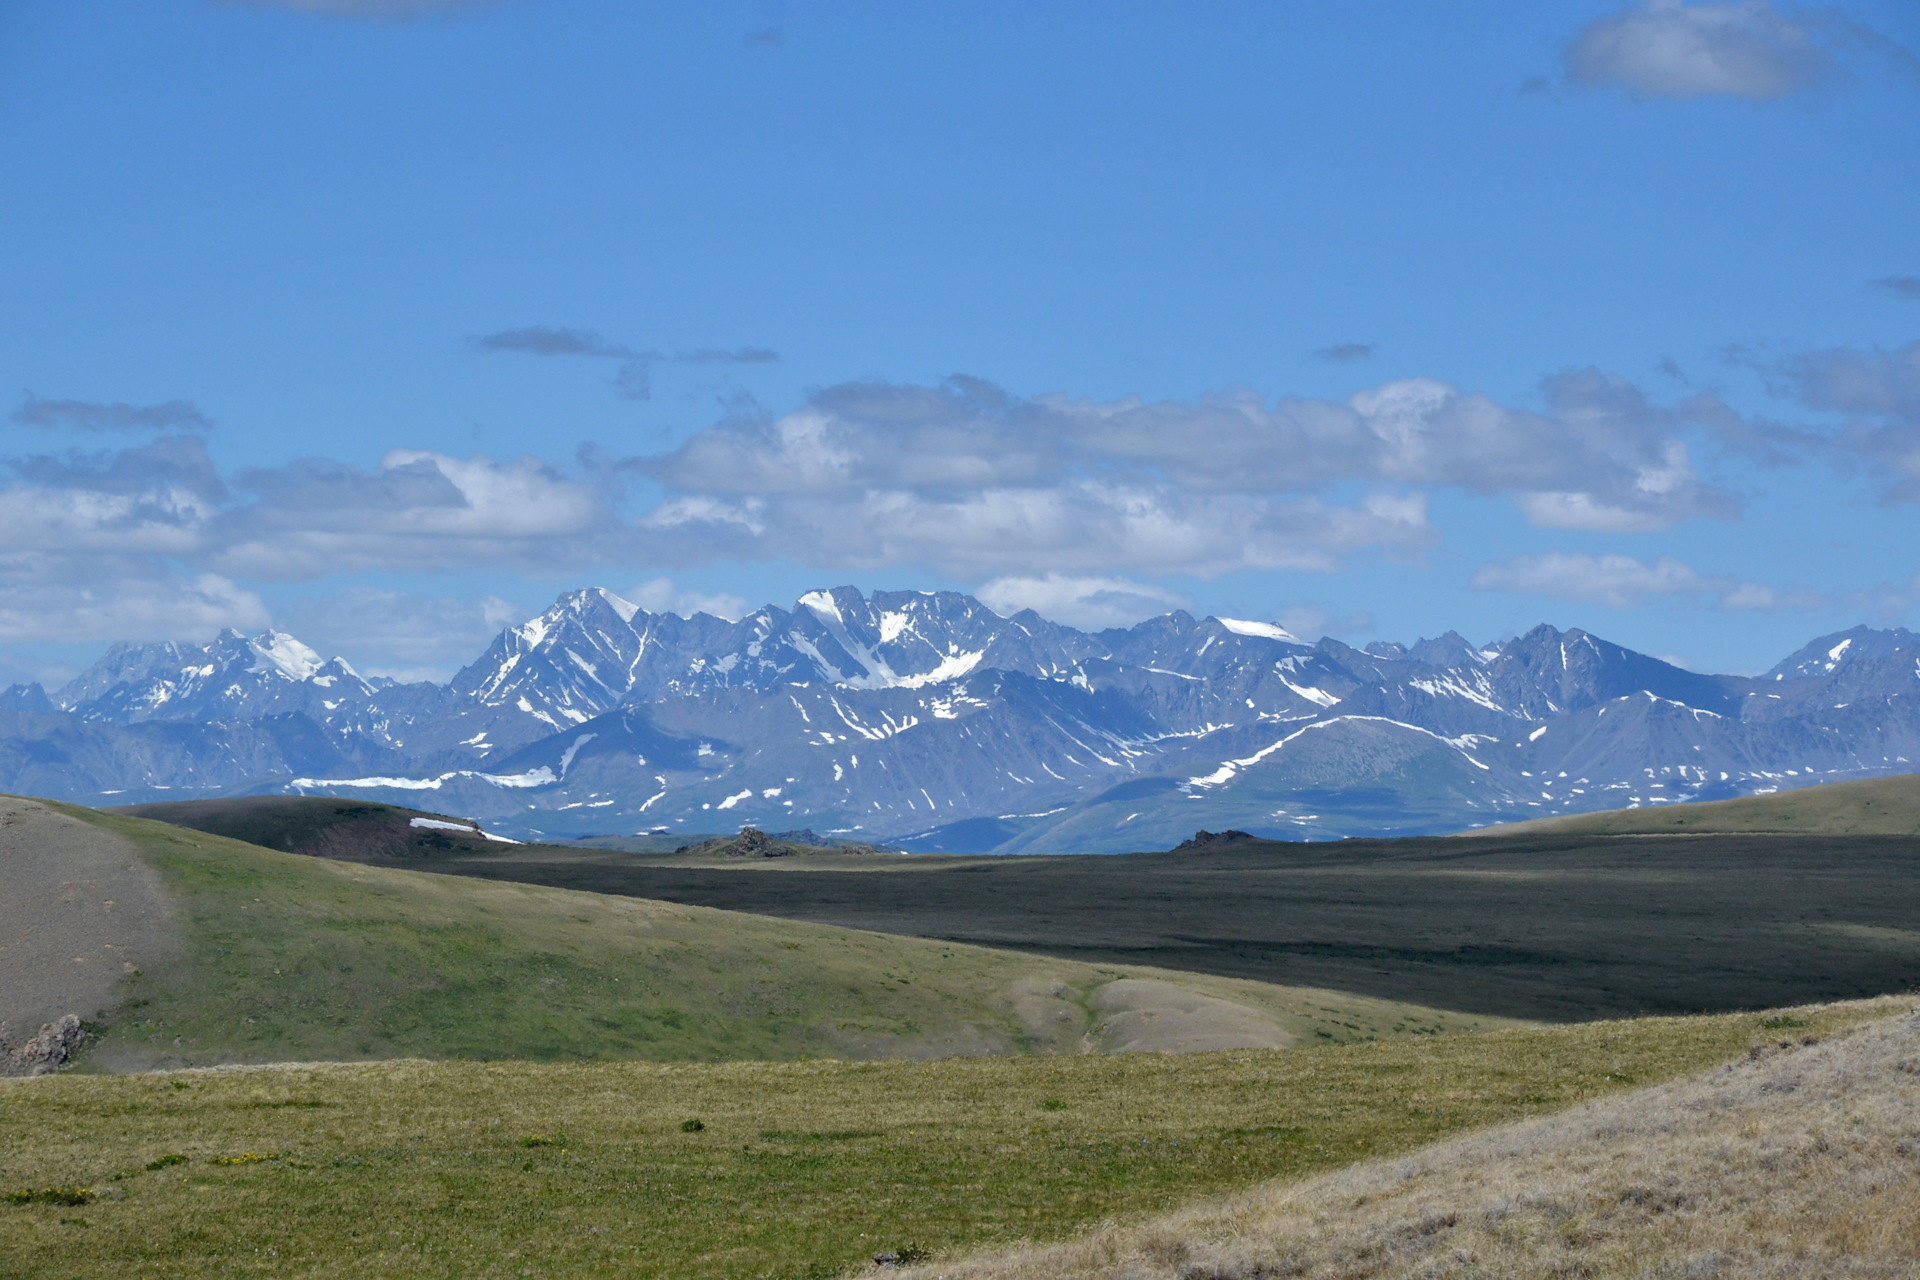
[0,1002,1907,1278]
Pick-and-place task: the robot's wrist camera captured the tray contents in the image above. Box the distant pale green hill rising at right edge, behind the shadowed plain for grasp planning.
[1463,773,1920,835]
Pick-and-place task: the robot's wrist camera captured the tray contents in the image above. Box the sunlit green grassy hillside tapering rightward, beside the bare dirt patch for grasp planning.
[45,806,1501,1071]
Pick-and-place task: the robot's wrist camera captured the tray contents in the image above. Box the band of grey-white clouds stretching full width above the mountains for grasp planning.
[0,355,1881,644]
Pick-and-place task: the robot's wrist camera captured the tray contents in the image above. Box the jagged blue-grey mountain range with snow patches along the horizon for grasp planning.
[0,587,1920,852]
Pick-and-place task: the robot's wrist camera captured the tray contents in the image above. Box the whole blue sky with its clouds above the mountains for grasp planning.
[0,0,1920,687]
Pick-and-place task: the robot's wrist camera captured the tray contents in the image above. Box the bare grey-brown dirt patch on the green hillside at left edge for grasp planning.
[0,796,171,1048]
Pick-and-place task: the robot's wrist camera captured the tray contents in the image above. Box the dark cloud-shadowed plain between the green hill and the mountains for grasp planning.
[382,833,1920,1021]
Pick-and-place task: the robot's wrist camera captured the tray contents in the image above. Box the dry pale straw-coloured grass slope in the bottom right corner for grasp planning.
[899,1011,1920,1280]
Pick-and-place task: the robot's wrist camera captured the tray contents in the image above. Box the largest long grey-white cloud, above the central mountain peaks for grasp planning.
[628,370,1738,578]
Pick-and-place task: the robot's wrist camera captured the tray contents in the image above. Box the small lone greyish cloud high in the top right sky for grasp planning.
[1567,0,1836,100]
